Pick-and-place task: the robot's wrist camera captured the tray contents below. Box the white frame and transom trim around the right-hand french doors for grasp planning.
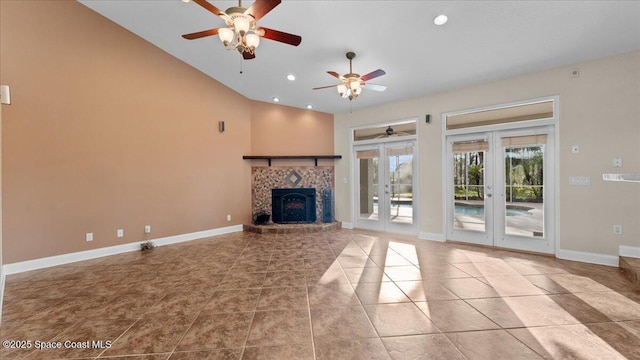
[442,96,560,255]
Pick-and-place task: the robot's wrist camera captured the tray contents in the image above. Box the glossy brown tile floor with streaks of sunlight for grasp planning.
[0,230,640,360]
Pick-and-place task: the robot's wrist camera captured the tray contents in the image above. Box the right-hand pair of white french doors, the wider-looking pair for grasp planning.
[445,126,555,253]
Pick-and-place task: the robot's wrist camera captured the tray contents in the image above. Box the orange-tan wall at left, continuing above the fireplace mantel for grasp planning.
[0,1,333,264]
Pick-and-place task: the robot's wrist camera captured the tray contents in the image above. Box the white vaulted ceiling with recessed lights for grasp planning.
[79,0,640,114]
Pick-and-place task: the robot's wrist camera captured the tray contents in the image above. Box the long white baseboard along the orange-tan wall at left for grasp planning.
[2,225,242,277]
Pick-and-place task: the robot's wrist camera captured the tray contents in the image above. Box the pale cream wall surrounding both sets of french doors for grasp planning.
[335,52,640,255]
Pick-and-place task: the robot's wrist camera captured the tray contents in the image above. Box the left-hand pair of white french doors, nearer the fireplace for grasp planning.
[354,141,417,233]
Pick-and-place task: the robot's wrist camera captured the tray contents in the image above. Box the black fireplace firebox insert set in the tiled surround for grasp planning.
[271,188,316,224]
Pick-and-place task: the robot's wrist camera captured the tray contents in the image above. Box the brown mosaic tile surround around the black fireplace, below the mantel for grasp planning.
[251,166,335,222]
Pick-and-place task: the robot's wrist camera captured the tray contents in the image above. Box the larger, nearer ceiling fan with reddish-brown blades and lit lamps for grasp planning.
[182,0,302,60]
